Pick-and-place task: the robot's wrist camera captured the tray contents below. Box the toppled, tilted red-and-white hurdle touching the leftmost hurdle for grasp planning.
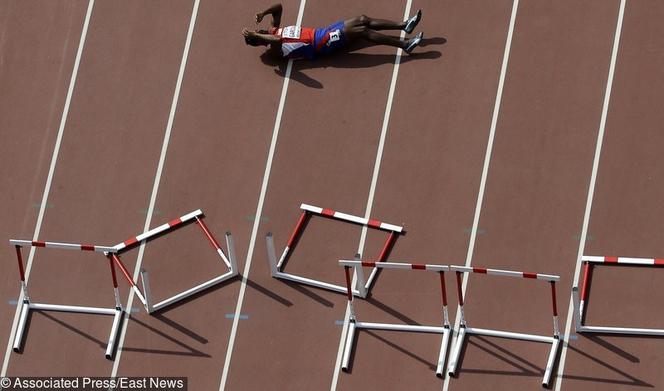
[109,209,238,314]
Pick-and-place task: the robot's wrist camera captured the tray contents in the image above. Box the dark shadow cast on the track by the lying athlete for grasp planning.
[261,37,447,89]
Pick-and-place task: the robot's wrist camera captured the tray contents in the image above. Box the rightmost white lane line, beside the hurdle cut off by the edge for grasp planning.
[555,0,627,391]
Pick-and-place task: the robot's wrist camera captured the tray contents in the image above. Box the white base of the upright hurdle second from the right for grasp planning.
[447,326,560,387]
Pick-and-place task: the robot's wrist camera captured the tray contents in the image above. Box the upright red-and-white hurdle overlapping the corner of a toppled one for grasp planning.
[339,259,451,377]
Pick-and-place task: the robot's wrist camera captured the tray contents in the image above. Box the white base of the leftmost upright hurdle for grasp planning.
[13,300,124,360]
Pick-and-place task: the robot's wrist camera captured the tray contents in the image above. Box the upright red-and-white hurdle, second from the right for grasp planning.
[447,265,560,387]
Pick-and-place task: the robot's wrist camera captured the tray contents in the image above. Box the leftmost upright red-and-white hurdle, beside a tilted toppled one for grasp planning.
[9,239,123,360]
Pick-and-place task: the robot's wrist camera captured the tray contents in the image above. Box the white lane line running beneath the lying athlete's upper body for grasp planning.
[219,0,307,391]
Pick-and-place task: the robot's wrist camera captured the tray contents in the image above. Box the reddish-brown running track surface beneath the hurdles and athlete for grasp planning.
[0,0,664,390]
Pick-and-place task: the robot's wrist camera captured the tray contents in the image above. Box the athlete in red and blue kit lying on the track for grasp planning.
[242,4,424,60]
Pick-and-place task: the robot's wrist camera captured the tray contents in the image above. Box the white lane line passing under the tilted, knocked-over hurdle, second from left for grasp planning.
[111,0,200,377]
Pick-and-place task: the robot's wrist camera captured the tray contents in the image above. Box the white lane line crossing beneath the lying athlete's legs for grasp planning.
[330,0,412,391]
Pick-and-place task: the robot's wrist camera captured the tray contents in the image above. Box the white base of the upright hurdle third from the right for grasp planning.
[341,320,451,377]
